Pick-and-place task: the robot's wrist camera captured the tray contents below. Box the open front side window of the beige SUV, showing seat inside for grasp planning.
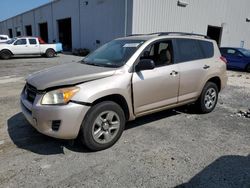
[140,40,173,67]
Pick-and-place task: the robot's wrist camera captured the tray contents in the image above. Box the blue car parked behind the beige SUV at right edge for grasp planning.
[220,47,250,72]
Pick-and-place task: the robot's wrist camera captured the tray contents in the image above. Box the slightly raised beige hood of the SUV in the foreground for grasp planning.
[26,63,117,90]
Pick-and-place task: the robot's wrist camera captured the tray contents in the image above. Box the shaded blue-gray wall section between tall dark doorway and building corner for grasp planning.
[80,0,126,50]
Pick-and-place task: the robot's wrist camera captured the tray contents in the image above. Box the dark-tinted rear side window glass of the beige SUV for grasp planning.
[176,39,214,62]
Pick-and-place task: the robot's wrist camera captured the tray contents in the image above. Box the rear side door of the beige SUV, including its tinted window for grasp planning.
[175,38,214,102]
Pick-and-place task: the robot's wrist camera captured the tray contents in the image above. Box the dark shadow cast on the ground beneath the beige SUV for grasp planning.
[7,110,182,155]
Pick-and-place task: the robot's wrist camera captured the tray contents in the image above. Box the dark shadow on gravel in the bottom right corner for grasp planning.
[175,155,250,188]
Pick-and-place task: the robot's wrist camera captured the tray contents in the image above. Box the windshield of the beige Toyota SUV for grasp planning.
[83,40,144,67]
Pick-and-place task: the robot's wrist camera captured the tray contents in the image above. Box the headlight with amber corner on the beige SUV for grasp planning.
[41,87,80,105]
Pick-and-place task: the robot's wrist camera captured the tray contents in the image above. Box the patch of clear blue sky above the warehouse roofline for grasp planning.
[0,0,51,21]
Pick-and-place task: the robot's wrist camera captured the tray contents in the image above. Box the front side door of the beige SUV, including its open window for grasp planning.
[132,40,179,115]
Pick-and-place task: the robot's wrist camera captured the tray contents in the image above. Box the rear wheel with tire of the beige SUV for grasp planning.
[196,82,219,114]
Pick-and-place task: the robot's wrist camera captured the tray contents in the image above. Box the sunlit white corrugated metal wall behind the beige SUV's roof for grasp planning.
[132,0,250,48]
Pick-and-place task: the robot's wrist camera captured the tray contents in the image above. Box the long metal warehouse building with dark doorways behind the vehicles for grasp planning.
[0,0,250,50]
